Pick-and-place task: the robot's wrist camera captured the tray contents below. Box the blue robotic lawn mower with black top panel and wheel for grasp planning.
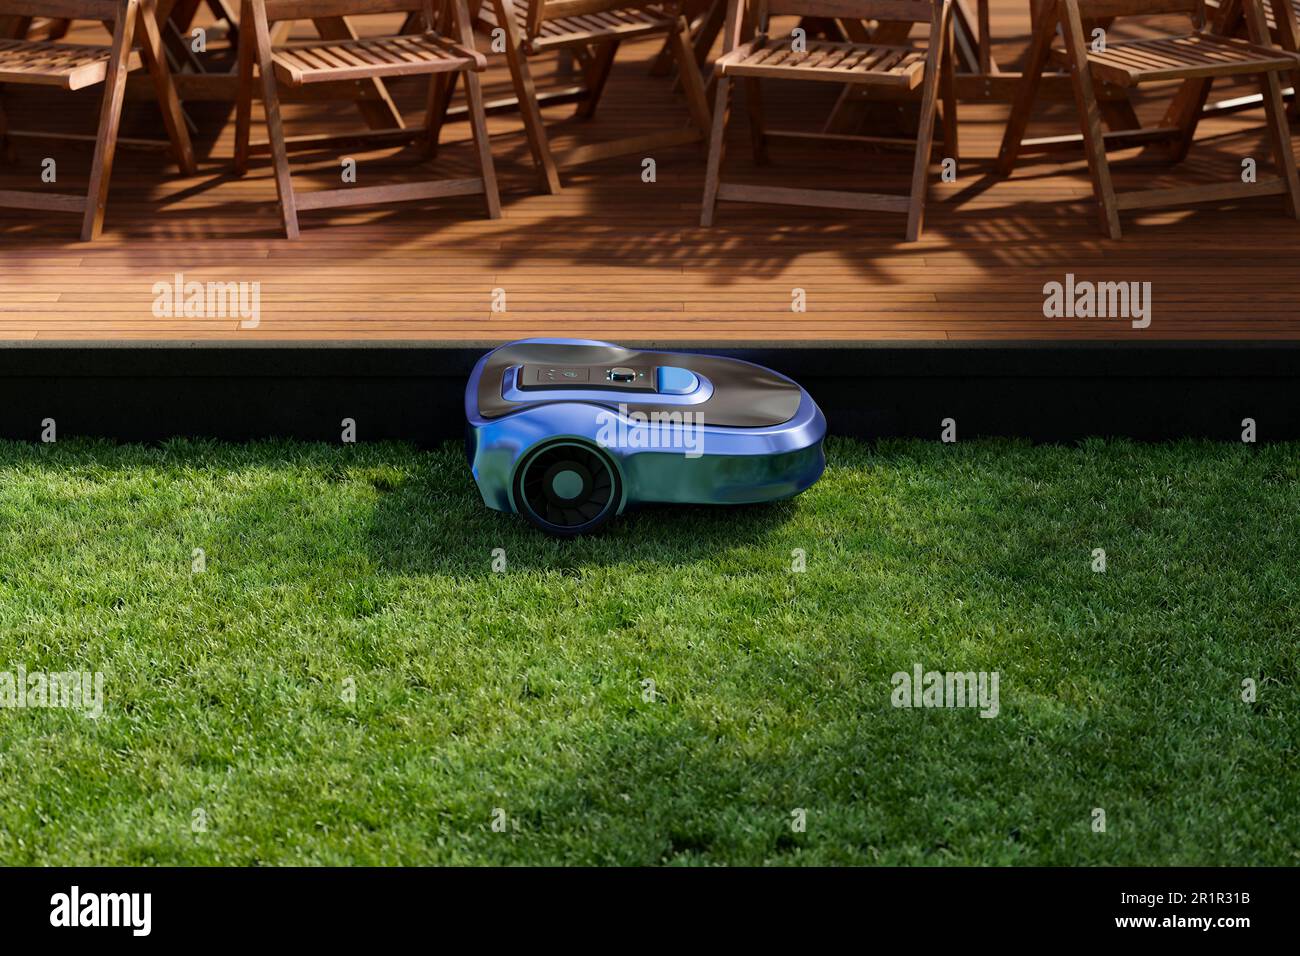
[465,338,826,536]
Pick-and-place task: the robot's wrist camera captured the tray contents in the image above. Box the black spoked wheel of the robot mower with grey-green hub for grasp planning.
[515,441,623,537]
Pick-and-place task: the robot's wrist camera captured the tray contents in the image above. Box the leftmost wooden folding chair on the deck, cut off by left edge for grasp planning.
[0,0,195,242]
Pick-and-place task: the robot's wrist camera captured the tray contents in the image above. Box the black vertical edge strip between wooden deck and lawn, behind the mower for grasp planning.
[0,341,1300,445]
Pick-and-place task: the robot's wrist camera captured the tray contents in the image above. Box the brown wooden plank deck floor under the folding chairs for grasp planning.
[0,3,1300,345]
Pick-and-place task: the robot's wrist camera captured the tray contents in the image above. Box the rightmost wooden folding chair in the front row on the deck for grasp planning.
[998,0,1300,239]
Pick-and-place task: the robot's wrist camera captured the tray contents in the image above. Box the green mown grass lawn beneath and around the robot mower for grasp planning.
[0,441,1300,865]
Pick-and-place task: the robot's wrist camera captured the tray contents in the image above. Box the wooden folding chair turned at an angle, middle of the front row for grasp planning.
[480,0,710,194]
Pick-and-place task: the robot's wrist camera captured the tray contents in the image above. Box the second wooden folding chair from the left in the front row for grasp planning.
[231,0,501,239]
